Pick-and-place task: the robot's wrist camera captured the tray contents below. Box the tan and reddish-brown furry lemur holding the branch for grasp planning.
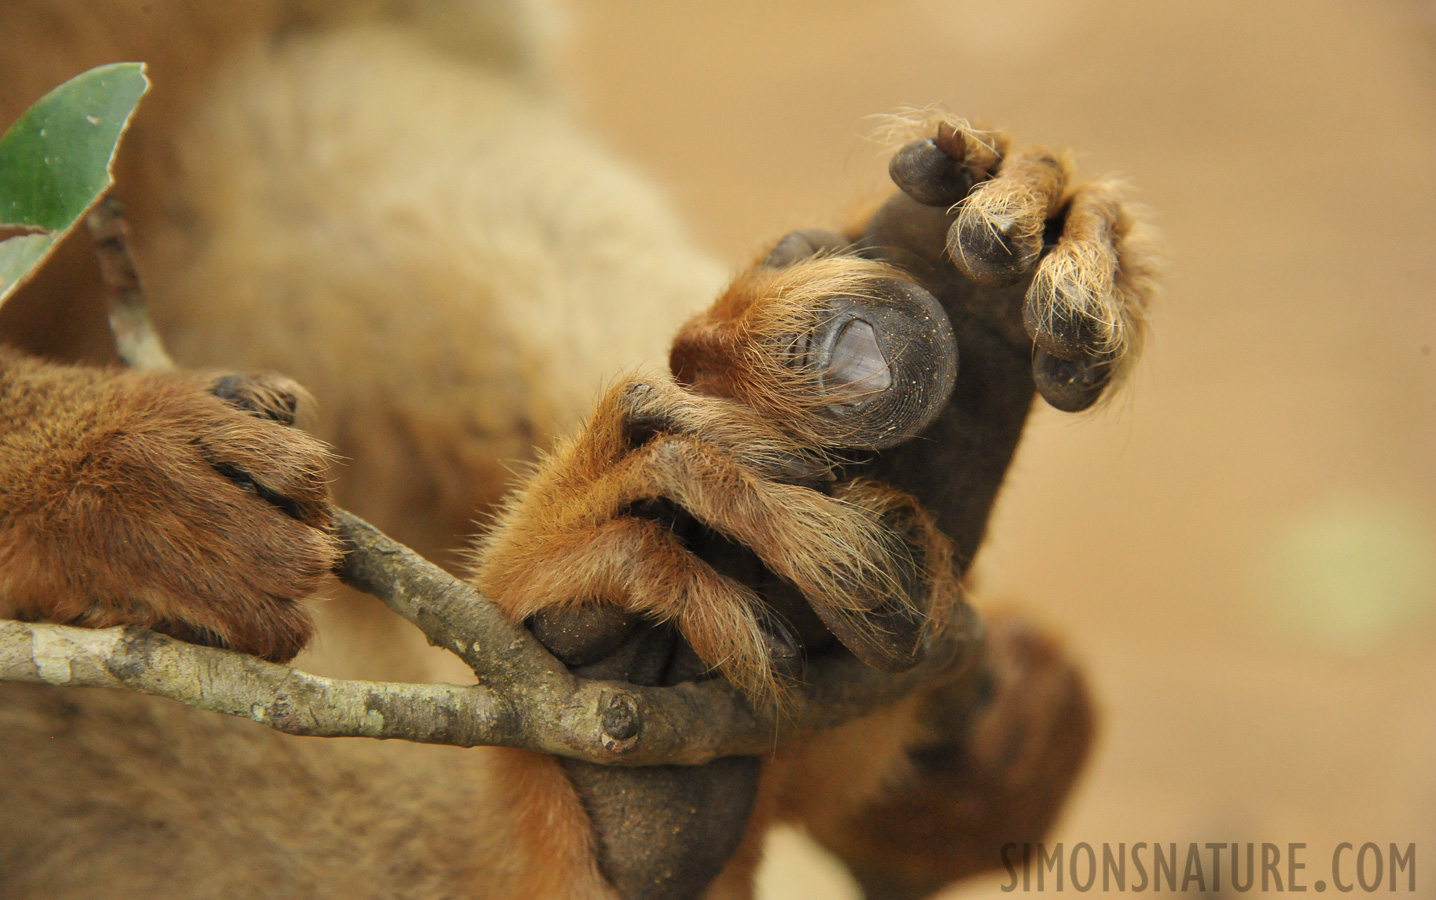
[0,0,1149,899]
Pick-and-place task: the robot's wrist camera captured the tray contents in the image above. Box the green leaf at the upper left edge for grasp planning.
[0,63,149,303]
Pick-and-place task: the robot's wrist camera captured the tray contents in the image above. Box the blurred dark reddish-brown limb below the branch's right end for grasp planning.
[808,619,1093,900]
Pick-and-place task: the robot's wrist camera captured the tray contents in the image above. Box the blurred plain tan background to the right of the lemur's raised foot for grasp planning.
[563,0,1436,899]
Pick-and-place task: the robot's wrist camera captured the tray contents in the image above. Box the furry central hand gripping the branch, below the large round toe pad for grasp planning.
[480,379,942,696]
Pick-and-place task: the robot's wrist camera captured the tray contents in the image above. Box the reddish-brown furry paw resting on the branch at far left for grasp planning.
[0,362,339,662]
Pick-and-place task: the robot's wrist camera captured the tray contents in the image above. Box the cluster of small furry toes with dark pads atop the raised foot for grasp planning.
[889,118,1153,412]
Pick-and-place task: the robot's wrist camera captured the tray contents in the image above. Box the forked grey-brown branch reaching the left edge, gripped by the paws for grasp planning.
[0,559,981,765]
